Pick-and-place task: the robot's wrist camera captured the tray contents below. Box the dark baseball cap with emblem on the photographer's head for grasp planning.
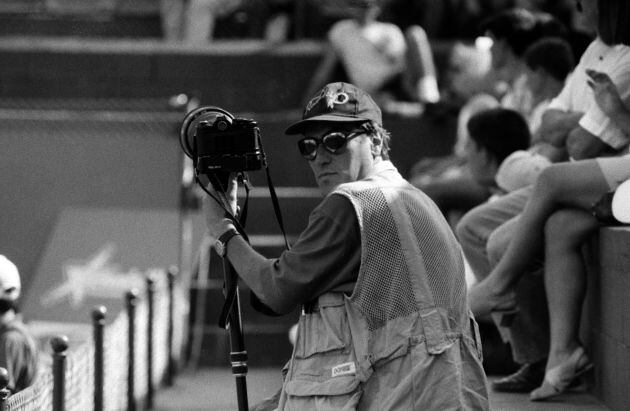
[284,82,383,134]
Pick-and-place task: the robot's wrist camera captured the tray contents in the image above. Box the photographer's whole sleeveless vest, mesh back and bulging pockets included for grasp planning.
[280,162,488,410]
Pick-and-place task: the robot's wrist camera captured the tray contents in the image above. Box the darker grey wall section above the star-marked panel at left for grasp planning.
[0,112,181,287]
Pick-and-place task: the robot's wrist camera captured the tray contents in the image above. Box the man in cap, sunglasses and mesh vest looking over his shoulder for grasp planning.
[204,83,488,410]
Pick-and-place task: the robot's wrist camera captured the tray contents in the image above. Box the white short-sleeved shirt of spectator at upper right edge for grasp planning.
[549,38,630,149]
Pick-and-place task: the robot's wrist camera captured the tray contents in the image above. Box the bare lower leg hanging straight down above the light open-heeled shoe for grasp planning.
[545,209,599,369]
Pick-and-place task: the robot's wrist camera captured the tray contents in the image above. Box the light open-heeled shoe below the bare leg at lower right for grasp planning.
[529,347,593,401]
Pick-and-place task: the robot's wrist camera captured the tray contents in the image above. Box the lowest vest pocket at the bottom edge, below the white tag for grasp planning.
[284,376,362,411]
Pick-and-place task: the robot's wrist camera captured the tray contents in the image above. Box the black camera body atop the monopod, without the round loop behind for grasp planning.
[195,116,265,174]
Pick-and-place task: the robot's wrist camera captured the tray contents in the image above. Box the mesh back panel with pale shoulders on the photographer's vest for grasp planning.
[335,170,469,366]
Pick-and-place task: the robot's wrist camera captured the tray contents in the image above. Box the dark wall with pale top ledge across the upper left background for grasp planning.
[0,37,452,113]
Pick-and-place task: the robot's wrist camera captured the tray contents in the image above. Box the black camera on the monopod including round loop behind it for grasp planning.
[180,107,266,174]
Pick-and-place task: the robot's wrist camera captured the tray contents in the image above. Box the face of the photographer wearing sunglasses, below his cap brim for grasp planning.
[304,124,380,195]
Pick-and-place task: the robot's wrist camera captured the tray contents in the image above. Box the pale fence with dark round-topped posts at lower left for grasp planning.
[0,268,185,411]
